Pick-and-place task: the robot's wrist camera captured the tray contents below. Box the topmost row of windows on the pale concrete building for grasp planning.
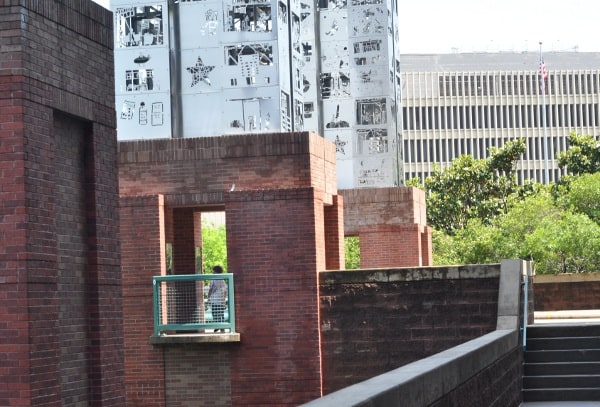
[438,73,599,96]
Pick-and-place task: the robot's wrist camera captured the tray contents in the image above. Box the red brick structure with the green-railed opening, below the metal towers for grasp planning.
[119,133,343,406]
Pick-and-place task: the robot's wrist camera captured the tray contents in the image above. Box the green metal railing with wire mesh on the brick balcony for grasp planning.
[152,273,235,335]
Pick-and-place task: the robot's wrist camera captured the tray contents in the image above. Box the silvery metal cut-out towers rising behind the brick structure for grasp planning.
[112,0,402,188]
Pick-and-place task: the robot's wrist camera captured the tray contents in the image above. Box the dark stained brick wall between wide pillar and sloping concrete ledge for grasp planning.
[320,265,499,394]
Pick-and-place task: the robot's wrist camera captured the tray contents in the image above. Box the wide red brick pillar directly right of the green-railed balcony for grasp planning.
[225,188,325,406]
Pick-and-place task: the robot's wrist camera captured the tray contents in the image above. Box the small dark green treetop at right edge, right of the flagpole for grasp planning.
[558,132,600,175]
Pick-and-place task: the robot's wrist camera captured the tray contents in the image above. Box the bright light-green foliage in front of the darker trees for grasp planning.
[433,184,600,274]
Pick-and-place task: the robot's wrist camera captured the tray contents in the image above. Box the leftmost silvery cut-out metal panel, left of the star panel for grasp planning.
[113,1,171,140]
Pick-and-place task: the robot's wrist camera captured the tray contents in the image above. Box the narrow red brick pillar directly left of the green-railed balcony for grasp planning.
[120,195,166,407]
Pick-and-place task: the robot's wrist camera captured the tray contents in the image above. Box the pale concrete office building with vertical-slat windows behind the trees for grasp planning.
[400,52,600,183]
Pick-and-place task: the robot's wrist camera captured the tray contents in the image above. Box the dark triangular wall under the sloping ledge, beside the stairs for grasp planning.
[431,347,523,407]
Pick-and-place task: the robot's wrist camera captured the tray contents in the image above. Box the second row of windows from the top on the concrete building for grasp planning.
[402,103,600,130]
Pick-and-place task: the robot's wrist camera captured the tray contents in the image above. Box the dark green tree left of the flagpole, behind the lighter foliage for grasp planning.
[425,139,525,234]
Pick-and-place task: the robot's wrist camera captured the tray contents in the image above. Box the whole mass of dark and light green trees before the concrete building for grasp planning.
[426,133,600,274]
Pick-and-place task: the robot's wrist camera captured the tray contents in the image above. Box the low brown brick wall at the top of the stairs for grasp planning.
[533,273,600,311]
